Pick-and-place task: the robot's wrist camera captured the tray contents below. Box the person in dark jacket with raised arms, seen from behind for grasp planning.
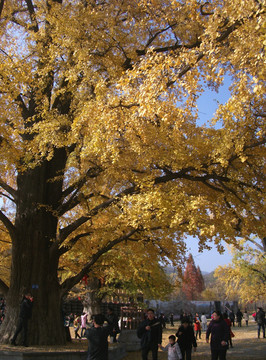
[86,314,112,360]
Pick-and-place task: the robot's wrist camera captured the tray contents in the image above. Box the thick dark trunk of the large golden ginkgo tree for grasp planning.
[0,150,66,345]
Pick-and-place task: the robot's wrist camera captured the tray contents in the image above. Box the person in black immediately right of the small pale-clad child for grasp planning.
[176,317,197,360]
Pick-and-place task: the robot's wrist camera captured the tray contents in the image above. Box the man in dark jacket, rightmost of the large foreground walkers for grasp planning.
[206,311,229,360]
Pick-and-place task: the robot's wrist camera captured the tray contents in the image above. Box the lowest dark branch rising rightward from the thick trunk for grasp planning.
[61,229,140,295]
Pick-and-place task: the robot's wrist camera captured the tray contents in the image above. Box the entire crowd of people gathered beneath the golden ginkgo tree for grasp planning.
[0,293,265,360]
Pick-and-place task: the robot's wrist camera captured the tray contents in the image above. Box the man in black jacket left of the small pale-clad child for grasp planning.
[137,309,162,360]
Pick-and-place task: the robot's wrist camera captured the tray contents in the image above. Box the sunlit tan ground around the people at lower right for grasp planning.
[124,323,266,360]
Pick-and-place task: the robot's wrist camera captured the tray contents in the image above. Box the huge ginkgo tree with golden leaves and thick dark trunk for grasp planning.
[0,0,265,344]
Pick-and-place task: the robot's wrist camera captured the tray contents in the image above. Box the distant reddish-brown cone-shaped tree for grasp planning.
[182,254,204,300]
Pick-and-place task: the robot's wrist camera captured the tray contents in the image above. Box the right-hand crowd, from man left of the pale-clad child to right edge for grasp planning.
[137,308,265,360]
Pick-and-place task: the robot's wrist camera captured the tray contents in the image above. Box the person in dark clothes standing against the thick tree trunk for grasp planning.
[11,293,33,346]
